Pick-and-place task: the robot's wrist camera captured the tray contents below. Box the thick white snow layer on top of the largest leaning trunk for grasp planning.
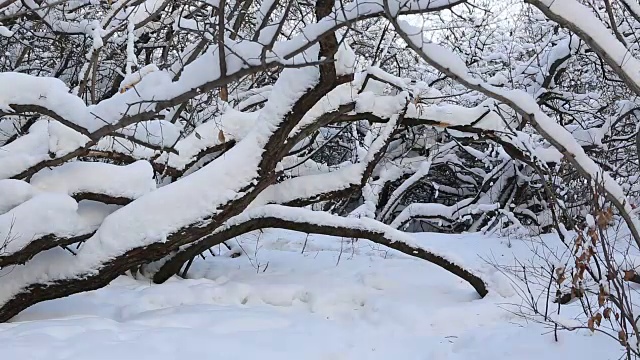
[0,47,319,301]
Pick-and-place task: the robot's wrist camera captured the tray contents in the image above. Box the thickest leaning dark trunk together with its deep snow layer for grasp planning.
[0,33,337,319]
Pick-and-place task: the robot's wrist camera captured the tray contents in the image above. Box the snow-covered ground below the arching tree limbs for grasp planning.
[0,230,621,360]
